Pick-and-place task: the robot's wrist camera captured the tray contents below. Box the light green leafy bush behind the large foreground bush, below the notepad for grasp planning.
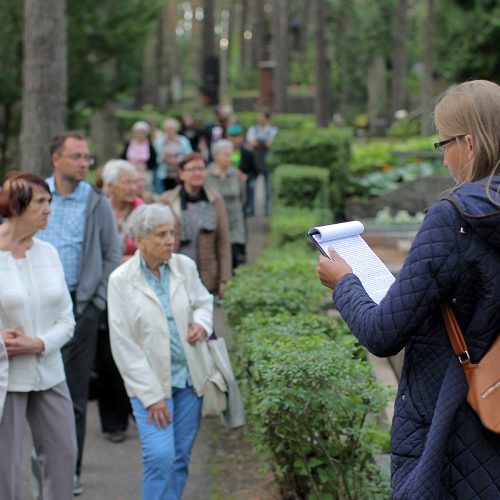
[223,245,325,325]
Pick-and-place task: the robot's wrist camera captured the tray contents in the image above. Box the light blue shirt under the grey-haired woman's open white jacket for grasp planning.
[141,257,193,389]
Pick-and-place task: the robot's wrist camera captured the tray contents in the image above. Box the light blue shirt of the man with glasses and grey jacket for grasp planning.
[37,177,91,292]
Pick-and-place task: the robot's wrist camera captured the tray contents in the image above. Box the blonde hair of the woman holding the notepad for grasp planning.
[434,80,500,185]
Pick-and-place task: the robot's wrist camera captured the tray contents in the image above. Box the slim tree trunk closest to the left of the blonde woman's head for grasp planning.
[420,0,435,137]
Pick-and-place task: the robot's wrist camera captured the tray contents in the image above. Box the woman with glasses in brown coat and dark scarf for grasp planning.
[163,153,231,297]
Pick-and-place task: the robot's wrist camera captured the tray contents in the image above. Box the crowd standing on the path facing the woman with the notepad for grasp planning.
[0,107,271,500]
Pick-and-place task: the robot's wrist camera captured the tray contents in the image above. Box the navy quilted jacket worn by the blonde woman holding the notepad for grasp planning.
[333,176,500,500]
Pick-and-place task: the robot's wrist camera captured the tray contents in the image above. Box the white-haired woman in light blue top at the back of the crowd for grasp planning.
[155,118,193,193]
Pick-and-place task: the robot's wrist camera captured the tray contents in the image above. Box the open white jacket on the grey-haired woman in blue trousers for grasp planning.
[108,250,213,408]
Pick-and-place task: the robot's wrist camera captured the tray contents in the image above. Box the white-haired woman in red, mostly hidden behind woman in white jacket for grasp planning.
[102,160,144,260]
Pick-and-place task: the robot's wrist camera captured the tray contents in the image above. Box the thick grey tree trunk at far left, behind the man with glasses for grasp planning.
[20,0,68,176]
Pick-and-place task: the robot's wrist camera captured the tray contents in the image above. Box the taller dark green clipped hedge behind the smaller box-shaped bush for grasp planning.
[270,128,352,213]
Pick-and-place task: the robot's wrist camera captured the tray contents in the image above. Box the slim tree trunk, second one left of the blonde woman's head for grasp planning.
[390,0,409,121]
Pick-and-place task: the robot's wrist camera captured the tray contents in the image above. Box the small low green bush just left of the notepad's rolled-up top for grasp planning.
[271,206,332,248]
